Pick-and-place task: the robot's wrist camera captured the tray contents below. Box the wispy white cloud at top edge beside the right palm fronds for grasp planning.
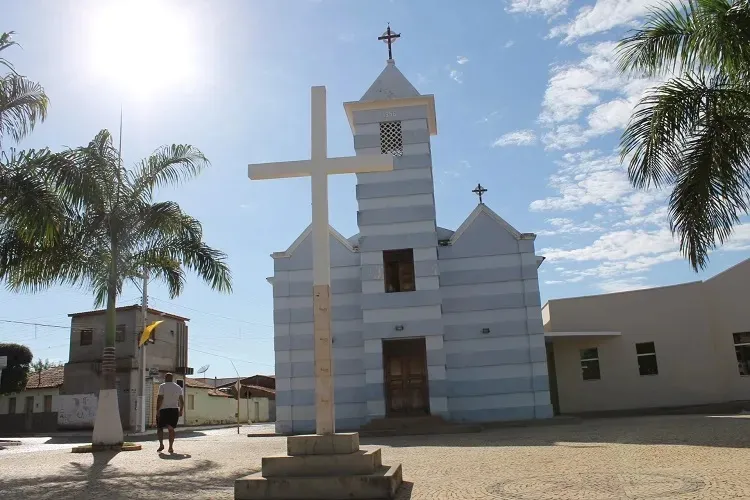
[550,0,655,43]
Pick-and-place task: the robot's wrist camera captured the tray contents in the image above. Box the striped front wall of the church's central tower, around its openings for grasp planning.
[350,105,448,428]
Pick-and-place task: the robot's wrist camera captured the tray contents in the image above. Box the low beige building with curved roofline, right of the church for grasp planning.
[542,259,750,414]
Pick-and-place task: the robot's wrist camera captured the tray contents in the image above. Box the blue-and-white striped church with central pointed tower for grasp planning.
[269,41,552,434]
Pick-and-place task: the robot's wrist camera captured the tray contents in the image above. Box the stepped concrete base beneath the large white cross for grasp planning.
[234,432,402,500]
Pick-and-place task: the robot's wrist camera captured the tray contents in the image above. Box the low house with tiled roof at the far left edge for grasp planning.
[0,366,64,435]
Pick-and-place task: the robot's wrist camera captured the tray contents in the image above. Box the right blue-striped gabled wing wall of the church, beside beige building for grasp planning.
[438,211,552,421]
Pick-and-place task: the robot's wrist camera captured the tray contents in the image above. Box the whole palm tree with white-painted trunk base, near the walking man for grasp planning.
[0,130,232,445]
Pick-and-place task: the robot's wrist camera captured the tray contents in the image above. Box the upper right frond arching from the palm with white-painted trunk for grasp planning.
[130,144,210,201]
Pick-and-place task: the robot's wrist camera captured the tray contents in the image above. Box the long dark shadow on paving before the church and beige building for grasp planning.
[360,415,750,448]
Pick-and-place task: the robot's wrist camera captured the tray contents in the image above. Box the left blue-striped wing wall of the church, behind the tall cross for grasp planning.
[273,234,364,433]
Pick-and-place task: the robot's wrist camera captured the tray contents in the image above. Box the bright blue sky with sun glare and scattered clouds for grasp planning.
[0,0,750,377]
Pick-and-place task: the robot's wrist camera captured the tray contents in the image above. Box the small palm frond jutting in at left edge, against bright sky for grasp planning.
[0,74,49,142]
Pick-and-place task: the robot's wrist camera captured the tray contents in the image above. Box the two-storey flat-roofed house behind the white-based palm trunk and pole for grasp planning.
[60,305,190,429]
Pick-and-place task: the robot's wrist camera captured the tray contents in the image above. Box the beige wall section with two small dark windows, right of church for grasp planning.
[546,282,737,413]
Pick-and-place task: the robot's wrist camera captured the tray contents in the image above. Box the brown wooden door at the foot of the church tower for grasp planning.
[383,338,430,417]
